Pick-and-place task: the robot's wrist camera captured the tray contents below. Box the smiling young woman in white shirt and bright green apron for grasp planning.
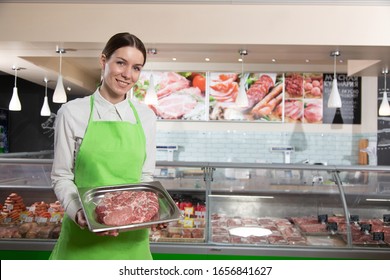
[50,33,156,260]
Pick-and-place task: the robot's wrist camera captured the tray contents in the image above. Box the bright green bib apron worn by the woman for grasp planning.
[50,96,152,260]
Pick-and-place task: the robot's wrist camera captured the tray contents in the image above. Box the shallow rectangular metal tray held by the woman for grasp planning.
[78,181,181,232]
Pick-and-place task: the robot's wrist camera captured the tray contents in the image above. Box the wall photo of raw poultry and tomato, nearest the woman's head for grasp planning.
[133,71,206,120]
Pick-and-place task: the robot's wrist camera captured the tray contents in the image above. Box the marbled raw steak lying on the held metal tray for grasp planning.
[95,191,159,226]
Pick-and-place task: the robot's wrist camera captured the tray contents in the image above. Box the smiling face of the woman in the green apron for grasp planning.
[100,47,144,104]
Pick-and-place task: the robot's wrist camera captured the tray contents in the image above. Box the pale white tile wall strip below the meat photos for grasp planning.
[157,131,377,165]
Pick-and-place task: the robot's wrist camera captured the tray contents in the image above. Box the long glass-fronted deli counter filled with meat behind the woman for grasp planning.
[0,158,390,259]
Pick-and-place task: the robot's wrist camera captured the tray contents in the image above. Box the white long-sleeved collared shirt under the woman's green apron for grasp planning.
[51,90,156,220]
